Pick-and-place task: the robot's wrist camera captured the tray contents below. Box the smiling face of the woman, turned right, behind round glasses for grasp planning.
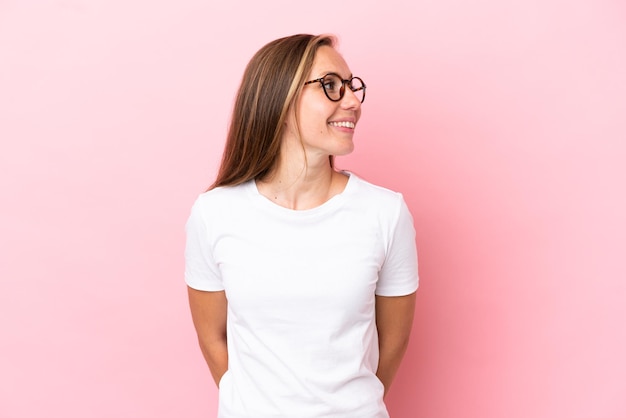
[287,46,361,158]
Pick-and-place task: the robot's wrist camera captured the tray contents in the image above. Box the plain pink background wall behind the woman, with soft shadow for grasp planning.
[0,0,626,418]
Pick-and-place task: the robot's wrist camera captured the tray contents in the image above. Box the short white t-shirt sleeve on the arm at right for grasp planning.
[376,195,419,296]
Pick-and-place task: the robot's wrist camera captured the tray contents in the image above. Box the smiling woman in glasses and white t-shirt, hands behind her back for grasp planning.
[185,35,418,418]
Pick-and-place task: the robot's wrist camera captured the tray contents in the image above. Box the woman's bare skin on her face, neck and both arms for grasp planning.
[189,46,415,395]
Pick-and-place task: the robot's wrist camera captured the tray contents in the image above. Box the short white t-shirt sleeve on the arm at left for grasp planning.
[185,199,224,291]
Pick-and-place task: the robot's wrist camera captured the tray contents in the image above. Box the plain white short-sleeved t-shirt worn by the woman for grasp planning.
[185,174,418,418]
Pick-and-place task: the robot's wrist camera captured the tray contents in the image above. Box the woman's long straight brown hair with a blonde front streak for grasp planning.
[209,34,336,189]
